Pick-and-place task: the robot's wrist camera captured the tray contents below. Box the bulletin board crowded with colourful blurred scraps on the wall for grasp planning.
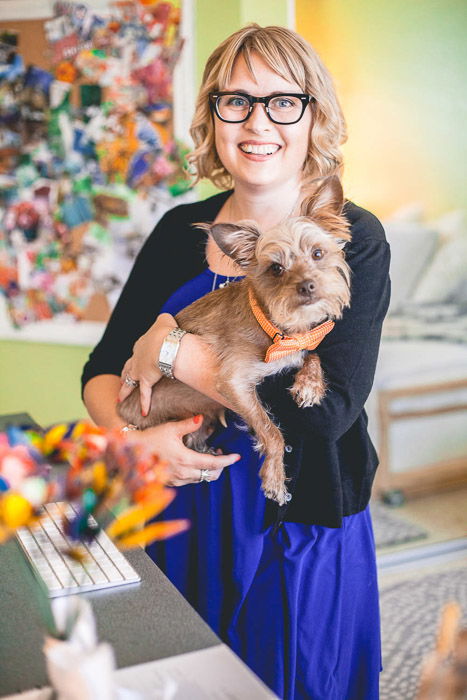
[0,0,193,343]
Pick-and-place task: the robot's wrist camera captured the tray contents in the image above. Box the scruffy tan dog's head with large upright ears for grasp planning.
[205,183,350,334]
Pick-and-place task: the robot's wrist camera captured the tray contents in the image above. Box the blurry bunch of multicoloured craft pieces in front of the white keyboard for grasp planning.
[0,421,189,558]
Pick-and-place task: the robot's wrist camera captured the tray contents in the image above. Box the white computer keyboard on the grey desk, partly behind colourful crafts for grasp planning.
[17,503,141,598]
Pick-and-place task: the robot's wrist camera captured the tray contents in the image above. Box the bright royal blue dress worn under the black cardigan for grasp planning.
[147,269,381,700]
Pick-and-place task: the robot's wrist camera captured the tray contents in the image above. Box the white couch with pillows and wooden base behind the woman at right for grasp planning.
[366,208,467,501]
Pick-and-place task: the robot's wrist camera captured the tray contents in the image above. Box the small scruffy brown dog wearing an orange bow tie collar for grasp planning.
[119,178,350,505]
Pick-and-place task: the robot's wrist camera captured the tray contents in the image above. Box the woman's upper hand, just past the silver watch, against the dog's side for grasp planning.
[118,314,177,416]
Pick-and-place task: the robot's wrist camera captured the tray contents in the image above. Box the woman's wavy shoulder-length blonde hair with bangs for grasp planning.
[188,24,347,189]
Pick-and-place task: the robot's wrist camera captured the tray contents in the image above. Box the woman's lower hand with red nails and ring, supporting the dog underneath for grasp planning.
[132,416,240,486]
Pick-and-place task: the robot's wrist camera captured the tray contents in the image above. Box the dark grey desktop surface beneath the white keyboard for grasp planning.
[0,421,221,696]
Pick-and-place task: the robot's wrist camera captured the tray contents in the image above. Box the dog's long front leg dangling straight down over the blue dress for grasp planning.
[217,377,288,505]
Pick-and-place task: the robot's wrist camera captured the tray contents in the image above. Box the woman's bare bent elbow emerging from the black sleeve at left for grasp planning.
[83,374,125,428]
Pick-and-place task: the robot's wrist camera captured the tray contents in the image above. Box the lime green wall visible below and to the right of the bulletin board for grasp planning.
[0,0,287,425]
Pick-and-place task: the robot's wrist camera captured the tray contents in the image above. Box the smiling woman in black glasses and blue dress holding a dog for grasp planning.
[83,25,389,700]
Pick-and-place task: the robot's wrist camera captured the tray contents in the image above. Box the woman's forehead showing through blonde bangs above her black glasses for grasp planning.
[222,53,302,96]
